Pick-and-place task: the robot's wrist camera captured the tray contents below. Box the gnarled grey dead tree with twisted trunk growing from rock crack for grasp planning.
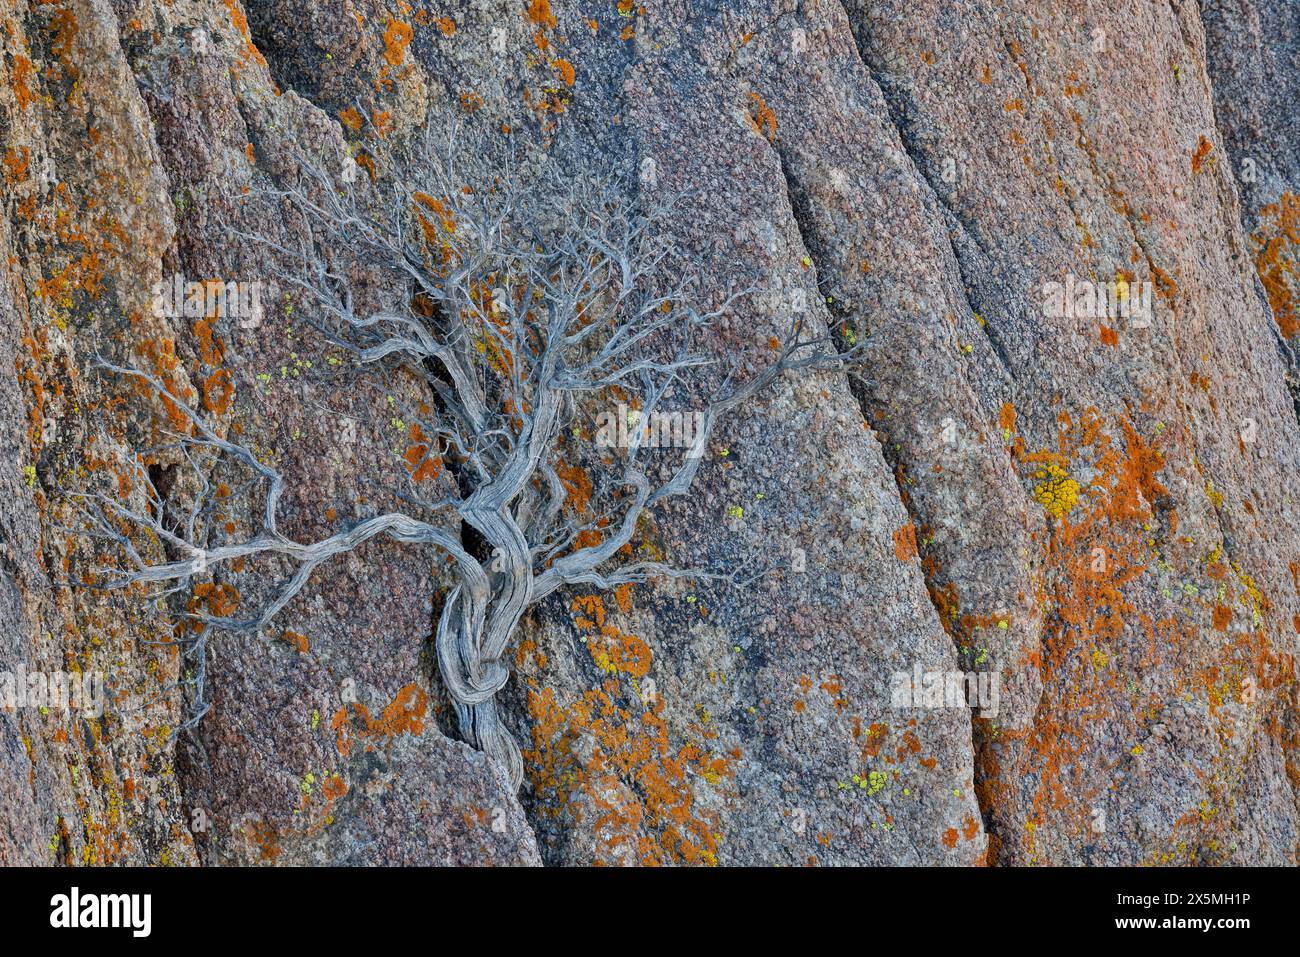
[73,128,855,789]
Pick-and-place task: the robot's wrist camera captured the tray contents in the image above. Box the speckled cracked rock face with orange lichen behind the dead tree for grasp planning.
[0,0,1300,866]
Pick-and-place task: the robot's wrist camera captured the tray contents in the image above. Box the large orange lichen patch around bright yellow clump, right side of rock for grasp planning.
[976,410,1294,863]
